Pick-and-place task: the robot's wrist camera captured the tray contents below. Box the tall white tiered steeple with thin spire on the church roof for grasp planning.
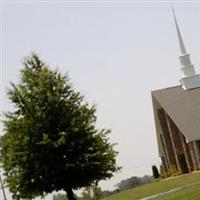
[172,7,200,90]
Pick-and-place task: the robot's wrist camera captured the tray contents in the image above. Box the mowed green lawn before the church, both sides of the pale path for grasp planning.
[103,172,200,200]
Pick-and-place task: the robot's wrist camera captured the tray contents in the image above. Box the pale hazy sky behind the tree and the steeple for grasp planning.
[0,0,200,199]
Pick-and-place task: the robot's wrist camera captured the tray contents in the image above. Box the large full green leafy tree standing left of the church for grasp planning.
[0,54,119,200]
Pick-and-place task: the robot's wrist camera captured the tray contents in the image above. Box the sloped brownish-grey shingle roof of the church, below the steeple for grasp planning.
[152,86,200,141]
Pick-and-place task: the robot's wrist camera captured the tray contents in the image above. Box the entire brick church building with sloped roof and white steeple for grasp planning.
[152,9,200,172]
